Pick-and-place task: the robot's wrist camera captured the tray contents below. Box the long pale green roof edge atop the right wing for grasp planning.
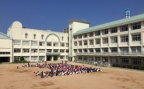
[74,14,144,35]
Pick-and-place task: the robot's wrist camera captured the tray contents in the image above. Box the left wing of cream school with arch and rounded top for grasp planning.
[7,21,69,61]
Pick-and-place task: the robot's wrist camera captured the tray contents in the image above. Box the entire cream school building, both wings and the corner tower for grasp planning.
[0,14,144,68]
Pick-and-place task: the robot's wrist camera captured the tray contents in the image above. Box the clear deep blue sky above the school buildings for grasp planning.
[0,0,144,34]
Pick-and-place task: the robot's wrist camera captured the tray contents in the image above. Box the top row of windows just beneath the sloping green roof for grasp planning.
[74,22,141,39]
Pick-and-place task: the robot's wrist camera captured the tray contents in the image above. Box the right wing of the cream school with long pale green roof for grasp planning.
[69,14,144,68]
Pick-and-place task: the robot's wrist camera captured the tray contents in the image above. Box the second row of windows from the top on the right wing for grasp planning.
[74,34,141,46]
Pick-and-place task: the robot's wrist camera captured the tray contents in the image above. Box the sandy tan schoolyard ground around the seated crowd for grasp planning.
[0,63,144,89]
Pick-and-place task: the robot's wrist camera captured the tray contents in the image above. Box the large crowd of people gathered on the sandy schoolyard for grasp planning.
[33,63,102,78]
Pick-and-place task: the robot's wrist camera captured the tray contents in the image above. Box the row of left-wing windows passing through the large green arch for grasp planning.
[14,40,69,47]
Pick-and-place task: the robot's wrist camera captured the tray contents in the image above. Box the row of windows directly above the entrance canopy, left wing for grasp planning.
[14,48,69,53]
